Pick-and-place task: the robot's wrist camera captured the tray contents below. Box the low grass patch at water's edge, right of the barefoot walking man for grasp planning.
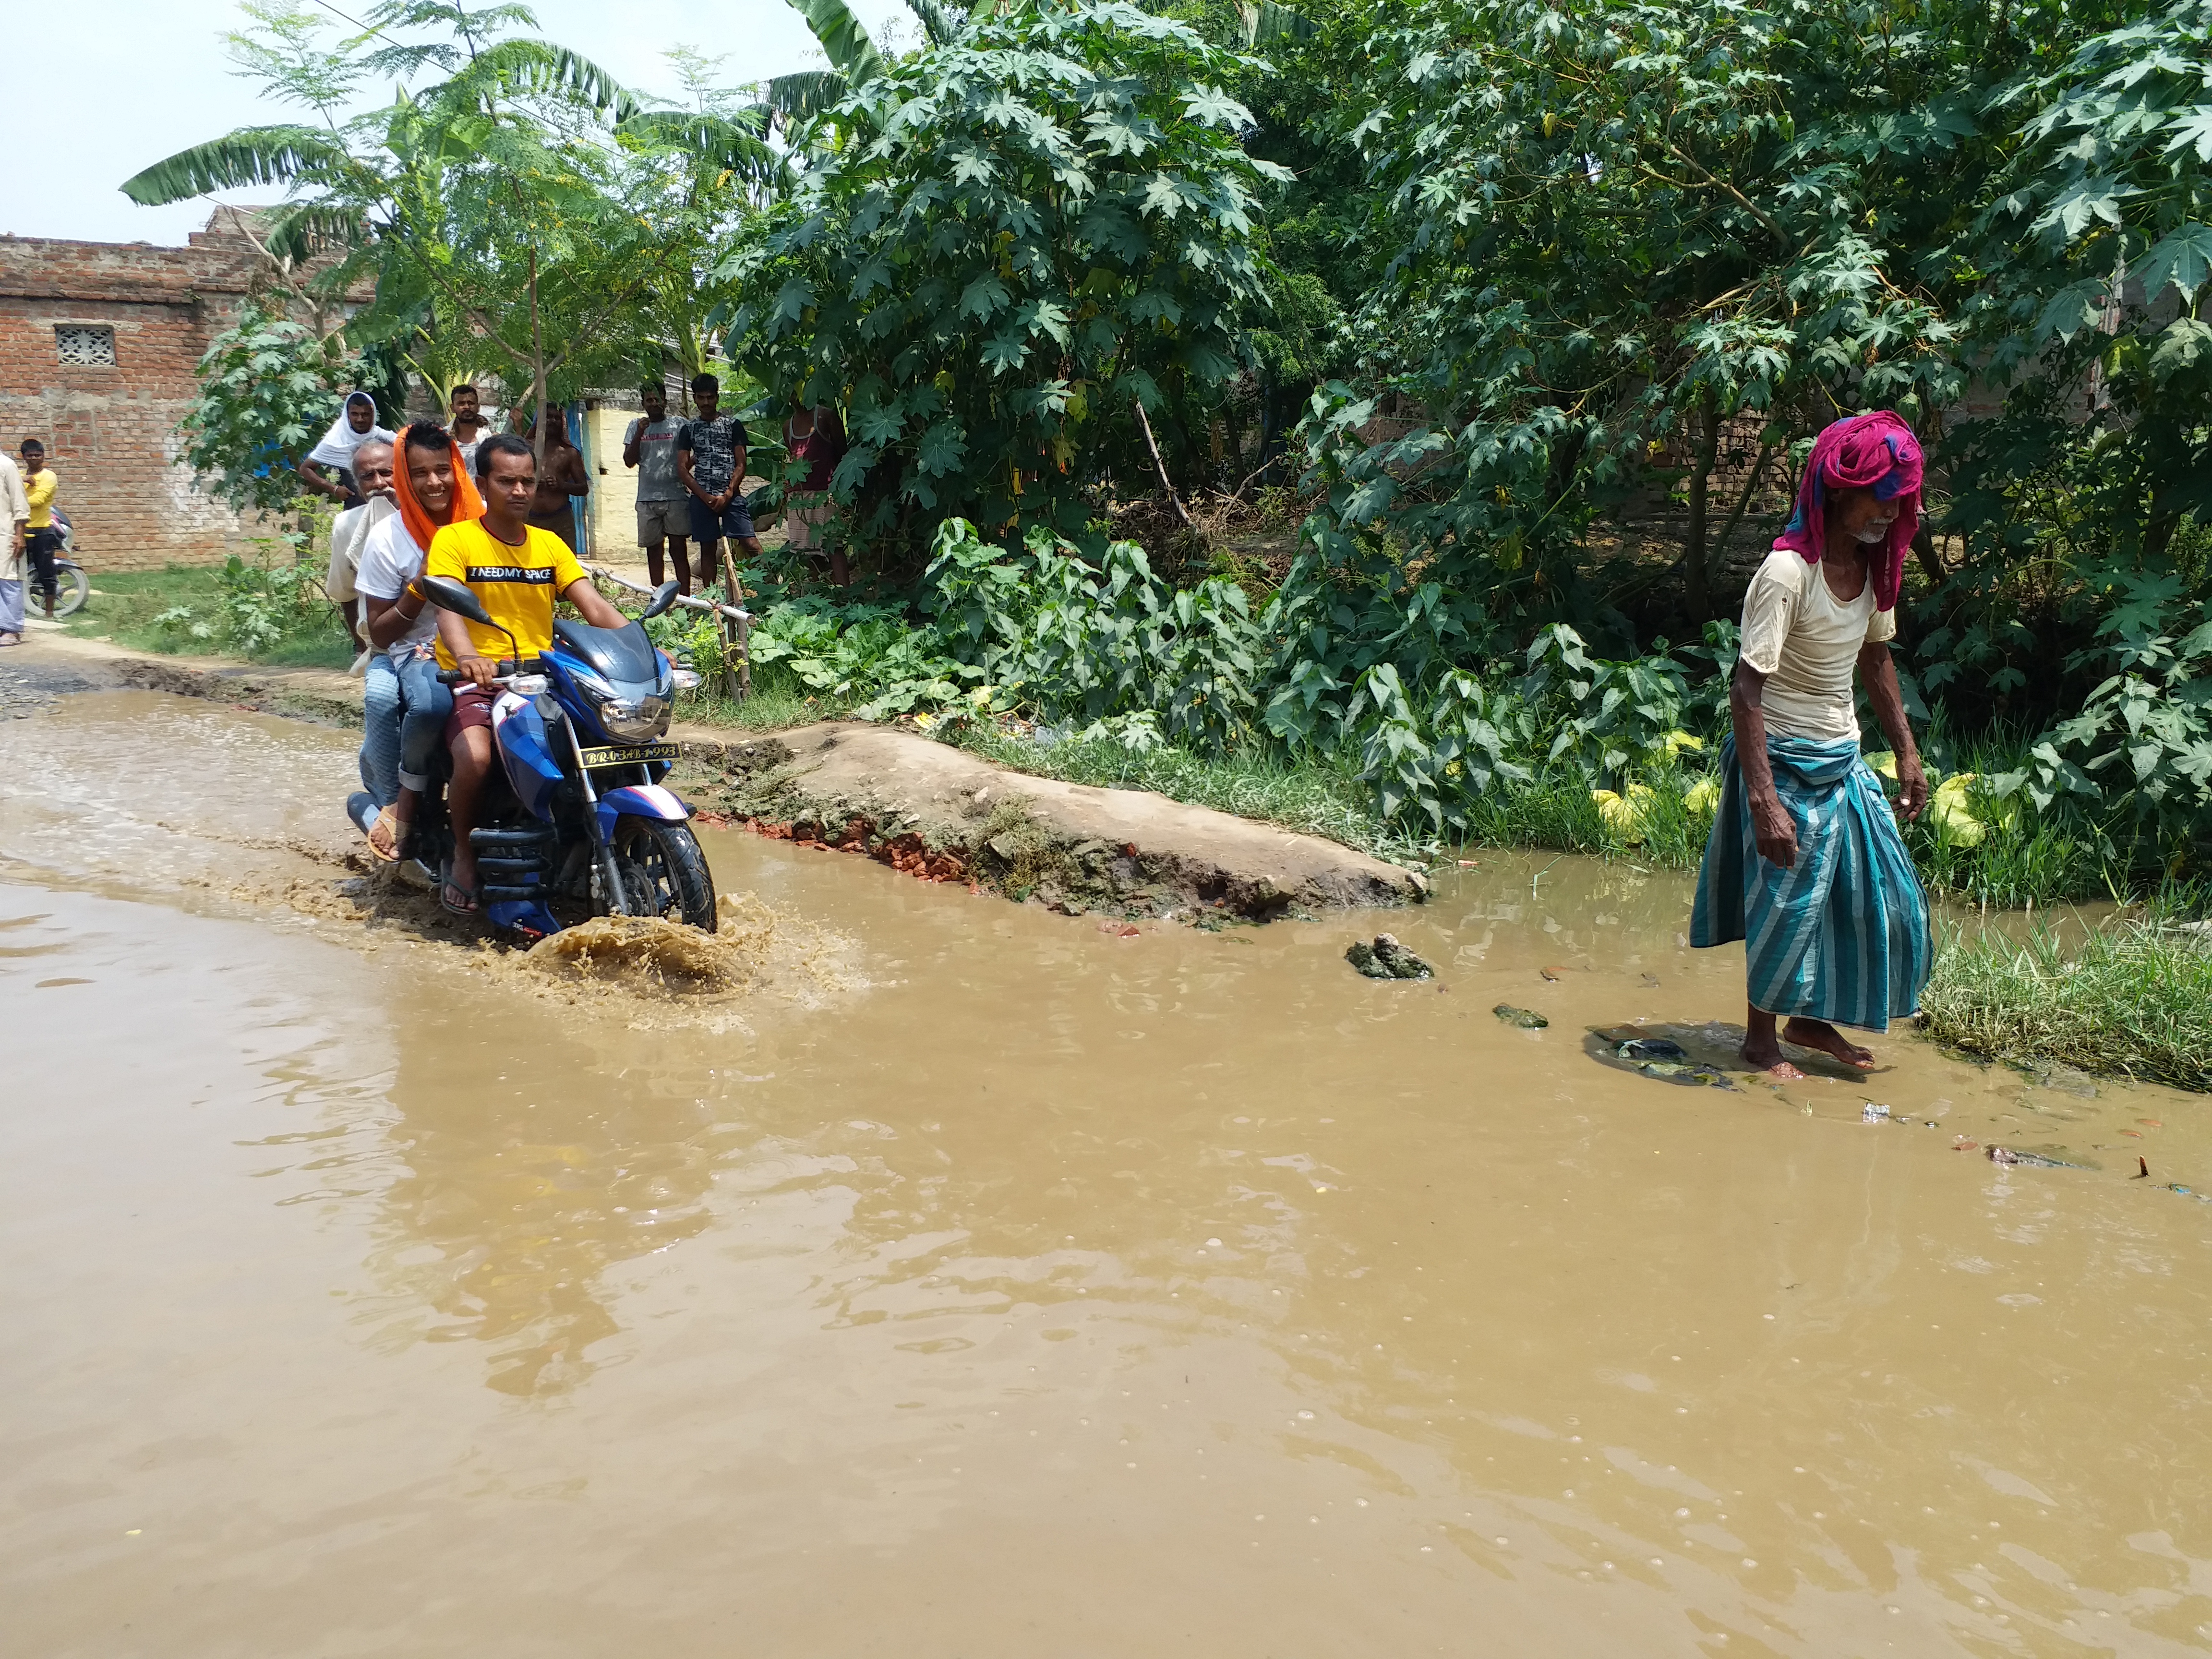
[1920,918,2212,1093]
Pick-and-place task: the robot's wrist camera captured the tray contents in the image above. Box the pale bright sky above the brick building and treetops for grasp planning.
[0,0,916,245]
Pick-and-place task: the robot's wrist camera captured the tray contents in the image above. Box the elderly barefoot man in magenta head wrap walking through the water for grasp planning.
[1690,414,1931,1077]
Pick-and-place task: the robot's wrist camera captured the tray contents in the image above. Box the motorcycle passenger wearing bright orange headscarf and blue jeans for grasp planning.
[354,421,484,863]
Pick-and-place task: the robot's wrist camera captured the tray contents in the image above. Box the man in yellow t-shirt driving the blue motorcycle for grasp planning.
[422,433,628,916]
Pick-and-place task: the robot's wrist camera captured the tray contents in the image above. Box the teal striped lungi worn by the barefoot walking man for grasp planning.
[1690,736,1933,1031]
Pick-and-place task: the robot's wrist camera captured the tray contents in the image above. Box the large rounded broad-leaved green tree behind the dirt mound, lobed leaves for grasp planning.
[723,0,1276,549]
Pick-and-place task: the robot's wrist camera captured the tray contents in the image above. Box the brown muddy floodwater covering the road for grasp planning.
[0,692,2212,1659]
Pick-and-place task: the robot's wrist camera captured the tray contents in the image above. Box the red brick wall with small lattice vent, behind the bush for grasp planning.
[0,217,312,571]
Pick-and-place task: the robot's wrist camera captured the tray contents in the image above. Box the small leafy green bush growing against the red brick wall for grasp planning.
[179,290,358,513]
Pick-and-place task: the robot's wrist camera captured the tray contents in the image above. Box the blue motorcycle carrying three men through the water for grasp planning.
[347,577,717,938]
